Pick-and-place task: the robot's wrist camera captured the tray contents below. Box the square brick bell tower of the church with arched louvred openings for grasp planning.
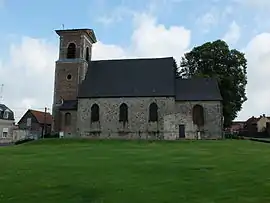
[52,29,97,135]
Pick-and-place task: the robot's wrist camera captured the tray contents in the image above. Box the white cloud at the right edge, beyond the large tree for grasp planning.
[236,33,270,119]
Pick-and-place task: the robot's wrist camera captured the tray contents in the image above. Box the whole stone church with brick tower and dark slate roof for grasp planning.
[53,29,223,140]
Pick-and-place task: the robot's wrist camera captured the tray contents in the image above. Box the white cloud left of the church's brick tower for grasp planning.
[0,37,57,120]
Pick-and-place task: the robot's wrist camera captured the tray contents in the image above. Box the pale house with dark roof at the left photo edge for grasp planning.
[0,104,14,143]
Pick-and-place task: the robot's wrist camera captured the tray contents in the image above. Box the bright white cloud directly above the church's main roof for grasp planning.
[132,14,191,58]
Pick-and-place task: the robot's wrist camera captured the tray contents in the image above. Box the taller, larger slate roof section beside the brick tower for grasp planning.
[78,57,175,98]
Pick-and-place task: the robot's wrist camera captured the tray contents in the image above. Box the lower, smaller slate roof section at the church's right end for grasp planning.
[175,78,222,101]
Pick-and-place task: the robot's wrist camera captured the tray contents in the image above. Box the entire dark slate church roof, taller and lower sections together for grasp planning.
[78,57,222,100]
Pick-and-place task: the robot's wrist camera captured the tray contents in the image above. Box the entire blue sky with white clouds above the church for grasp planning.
[0,0,270,121]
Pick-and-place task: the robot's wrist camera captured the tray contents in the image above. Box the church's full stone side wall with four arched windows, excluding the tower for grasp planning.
[77,97,222,140]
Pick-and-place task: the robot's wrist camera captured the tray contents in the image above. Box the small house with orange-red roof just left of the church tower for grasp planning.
[18,109,52,137]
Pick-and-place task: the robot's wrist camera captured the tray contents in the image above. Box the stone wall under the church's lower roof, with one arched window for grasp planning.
[175,101,223,139]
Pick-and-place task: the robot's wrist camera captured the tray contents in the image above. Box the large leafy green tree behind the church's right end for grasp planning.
[179,40,247,127]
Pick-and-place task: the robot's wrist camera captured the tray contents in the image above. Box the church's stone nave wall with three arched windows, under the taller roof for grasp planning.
[77,97,175,139]
